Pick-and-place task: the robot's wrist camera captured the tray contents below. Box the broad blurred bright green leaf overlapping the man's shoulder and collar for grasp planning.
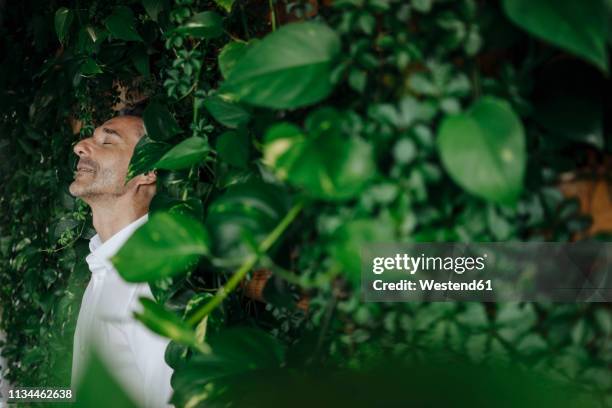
[111,213,209,282]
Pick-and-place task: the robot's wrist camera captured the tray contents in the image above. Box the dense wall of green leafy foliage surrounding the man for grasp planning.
[0,0,612,405]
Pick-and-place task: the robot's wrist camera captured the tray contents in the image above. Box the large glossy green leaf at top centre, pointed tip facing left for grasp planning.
[221,22,340,109]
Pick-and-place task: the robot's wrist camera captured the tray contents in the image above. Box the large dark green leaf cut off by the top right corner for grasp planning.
[503,0,608,71]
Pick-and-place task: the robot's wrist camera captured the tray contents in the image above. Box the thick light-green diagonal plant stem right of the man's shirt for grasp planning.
[187,202,303,327]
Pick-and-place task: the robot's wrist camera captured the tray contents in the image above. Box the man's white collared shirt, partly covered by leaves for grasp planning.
[71,214,172,408]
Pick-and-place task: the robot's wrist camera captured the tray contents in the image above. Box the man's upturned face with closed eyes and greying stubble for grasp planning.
[70,116,144,200]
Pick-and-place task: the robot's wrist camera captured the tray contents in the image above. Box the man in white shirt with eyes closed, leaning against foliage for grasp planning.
[70,116,172,407]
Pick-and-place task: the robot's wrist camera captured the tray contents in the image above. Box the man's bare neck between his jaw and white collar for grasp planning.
[89,194,149,242]
